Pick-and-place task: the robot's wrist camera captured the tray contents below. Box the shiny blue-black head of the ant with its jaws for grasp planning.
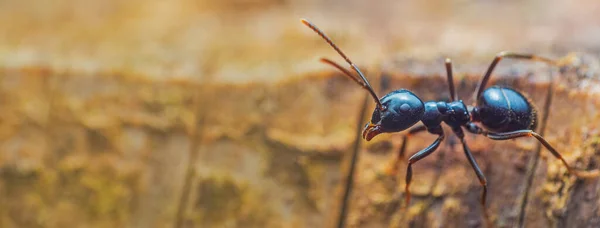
[363,89,425,141]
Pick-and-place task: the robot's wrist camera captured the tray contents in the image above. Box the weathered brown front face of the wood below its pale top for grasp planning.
[1,64,600,227]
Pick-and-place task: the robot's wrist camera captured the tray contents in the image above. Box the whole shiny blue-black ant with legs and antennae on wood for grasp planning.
[301,19,600,214]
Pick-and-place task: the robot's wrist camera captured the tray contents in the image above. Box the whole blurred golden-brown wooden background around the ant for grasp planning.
[0,0,600,227]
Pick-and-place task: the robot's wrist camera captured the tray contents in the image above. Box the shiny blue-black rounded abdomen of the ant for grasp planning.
[471,86,537,132]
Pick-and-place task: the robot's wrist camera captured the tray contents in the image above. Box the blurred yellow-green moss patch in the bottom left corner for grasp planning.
[1,161,139,227]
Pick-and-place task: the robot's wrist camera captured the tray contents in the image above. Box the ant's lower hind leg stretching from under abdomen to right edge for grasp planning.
[482,130,600,178]
